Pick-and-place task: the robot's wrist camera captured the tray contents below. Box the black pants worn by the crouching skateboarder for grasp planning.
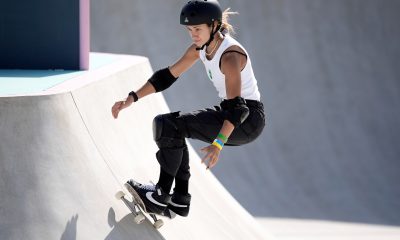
[154,100,265,180]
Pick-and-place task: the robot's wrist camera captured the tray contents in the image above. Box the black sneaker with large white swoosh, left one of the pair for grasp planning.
[125,179,171,214]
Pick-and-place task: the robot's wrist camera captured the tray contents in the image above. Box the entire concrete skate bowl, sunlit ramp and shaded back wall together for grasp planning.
[0,0,400,240]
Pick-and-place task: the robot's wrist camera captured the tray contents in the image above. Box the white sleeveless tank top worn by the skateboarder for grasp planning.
[199,35,260,101]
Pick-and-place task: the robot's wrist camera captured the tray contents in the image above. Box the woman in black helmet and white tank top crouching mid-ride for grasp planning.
[112,0,265,216]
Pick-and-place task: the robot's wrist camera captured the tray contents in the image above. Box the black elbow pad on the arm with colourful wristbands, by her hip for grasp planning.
[221,97,250,128]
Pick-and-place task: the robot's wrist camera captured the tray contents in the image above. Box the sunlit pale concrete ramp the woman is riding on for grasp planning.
[0,55,272,240]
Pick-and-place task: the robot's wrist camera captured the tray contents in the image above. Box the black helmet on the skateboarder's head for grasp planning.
[180,0,222,25]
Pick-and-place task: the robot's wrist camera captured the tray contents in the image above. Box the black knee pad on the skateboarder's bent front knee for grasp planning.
[153,112,185,148]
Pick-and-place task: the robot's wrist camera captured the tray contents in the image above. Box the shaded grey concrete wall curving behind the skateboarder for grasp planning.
[92,0,400,227]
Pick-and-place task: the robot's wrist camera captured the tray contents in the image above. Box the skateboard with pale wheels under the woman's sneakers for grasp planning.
[115,183,176,229]
